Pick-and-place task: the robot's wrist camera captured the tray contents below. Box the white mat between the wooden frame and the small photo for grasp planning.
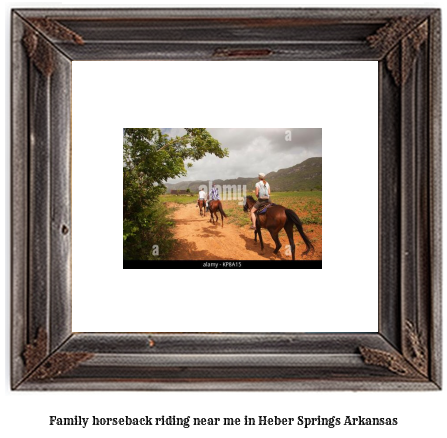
[72,61,378,332]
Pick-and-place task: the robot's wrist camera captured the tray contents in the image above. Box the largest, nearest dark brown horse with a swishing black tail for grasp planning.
[244,196,314,260]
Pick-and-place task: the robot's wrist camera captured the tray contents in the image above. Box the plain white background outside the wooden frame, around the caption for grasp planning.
[0,1,447,438]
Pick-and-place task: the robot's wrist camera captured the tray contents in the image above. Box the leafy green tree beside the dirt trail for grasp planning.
[123,128,228,259]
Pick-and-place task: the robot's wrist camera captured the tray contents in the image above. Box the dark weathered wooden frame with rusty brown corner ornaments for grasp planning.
[11,9,441,390]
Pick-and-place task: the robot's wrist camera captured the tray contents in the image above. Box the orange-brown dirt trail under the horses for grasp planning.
[171,204,321,260]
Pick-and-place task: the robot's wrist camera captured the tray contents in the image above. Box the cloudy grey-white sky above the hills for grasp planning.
[162,128,322,183]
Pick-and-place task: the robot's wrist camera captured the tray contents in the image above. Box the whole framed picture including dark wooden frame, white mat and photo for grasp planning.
[11,9,442,390]
